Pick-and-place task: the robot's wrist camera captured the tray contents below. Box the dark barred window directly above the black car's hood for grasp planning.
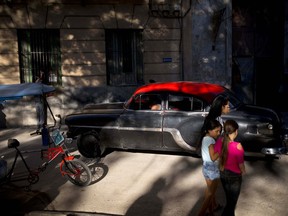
[105,29,143,86]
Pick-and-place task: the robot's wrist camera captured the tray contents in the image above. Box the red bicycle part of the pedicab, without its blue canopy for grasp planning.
[0,116,92,188]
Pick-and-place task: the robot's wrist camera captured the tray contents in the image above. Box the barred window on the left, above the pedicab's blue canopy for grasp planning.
[17,29,62,85]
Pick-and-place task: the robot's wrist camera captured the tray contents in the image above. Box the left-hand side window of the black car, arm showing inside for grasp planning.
[129,94,162,111]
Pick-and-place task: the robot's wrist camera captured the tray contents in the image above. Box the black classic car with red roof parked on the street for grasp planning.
[65,81,287,158]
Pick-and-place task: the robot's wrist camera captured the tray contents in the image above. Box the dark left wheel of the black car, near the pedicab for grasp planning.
[77,131,101,158]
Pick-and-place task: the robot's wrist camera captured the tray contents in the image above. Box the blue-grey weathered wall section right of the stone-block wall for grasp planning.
[184,0,232,87]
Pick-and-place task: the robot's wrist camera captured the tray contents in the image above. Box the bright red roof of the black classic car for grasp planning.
[133,81,226,102]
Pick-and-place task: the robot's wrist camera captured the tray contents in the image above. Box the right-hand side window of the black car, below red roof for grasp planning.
[168,95,203,111]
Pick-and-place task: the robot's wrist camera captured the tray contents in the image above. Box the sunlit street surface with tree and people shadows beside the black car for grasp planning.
[0,128,288,216]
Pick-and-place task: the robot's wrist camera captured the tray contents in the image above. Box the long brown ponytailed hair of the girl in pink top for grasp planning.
[220,119,239,170]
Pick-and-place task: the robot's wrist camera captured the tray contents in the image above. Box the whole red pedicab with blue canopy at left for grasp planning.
[0,83,92,187]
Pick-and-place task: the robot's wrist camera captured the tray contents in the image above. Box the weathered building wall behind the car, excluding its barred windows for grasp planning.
[0,0,231,127]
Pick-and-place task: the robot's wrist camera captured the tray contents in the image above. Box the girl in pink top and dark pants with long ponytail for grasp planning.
[214,120,245,216]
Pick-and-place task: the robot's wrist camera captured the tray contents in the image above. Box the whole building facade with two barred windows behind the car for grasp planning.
[0,0,285,127]
